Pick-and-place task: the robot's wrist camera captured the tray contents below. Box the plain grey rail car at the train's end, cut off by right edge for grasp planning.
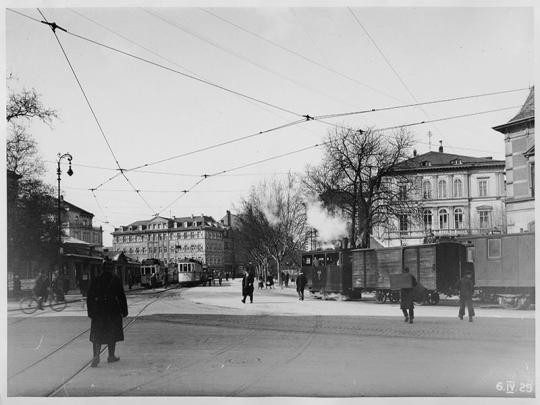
[457,232,535,307]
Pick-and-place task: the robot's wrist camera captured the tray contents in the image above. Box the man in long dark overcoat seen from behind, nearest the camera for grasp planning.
[87,263,128,367]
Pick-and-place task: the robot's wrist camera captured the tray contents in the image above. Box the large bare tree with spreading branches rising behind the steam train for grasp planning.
[304,129,420,247]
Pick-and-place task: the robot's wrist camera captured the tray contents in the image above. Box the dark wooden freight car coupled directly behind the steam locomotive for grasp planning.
[351,242,468,304]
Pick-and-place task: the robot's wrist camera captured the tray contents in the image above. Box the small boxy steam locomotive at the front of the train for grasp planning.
[302,250,352,296]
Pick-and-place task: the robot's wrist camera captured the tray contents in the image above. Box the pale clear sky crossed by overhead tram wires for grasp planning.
[5,3,534,246]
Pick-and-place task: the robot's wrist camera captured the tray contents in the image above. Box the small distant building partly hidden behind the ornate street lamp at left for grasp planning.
[60,200,103,246]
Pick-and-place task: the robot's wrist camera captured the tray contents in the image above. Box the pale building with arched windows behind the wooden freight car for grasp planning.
[374,145,506,246]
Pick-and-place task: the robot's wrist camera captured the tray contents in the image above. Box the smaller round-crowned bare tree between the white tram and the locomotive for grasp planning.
[239,175,307,282]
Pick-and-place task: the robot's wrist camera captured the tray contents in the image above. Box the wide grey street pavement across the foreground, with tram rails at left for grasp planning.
[8,310,534,397]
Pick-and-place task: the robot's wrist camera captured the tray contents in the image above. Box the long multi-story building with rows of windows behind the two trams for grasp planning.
[112,211,227,271]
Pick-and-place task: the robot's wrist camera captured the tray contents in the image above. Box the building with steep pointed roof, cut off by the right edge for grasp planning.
[493,87,534,233]
